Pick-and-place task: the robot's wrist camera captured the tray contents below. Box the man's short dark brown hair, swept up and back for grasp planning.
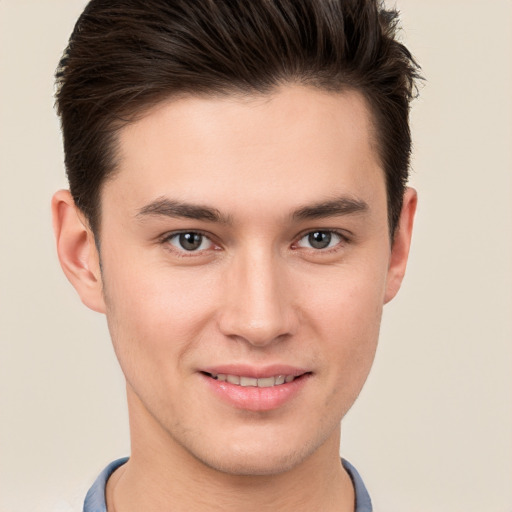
[56,0,419,235]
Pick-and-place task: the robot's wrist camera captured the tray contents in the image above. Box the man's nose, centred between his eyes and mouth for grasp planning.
[219,250,297,347]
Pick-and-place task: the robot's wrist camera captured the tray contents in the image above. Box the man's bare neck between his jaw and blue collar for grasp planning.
[107,386,354,512]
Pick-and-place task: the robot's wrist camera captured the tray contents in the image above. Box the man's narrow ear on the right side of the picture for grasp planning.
[384,187,418,304]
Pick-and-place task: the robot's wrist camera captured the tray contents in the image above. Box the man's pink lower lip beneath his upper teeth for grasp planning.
[201,374,311,412]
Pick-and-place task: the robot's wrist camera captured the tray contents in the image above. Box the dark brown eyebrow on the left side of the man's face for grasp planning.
[136,197,231,224]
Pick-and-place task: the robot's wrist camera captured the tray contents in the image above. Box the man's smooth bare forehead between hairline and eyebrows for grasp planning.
[102,86,384,220]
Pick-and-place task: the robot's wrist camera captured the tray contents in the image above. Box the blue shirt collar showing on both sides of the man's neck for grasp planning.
[84,457,372,512]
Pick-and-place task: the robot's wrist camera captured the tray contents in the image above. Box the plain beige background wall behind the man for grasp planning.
[0,0,512,512]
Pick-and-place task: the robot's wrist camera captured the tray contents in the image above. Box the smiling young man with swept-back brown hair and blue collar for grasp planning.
[52,0,417,512]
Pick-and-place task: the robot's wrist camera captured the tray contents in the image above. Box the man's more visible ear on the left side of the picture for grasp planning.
[52,190,106,313]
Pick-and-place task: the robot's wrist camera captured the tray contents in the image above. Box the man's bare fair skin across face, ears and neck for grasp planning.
[53,85,416,512]
